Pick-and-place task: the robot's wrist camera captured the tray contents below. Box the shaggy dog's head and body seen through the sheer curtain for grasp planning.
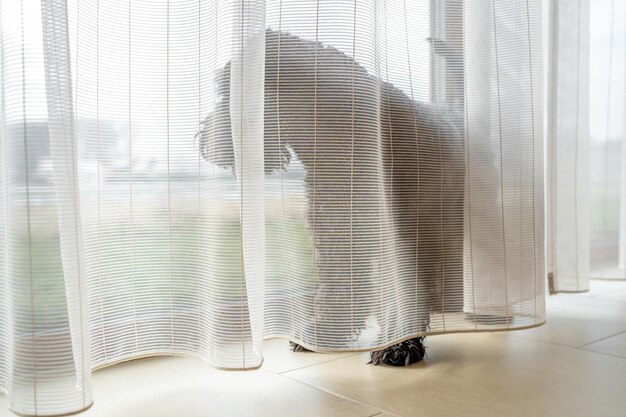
[198,30,465,364]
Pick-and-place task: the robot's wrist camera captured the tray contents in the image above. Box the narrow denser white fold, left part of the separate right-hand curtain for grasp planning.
[546,0,596,293]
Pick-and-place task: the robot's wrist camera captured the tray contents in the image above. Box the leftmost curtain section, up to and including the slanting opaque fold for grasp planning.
[0,1,91,415]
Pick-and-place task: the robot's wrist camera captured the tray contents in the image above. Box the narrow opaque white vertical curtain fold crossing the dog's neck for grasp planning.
[226,0,265,368]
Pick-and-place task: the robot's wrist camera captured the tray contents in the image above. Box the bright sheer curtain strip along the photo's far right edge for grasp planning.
[589,0,626,279]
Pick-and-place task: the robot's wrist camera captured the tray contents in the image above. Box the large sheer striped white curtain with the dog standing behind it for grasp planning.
[0,0,540,415]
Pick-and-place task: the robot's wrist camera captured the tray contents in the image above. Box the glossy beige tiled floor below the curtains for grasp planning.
[0,281,626,417]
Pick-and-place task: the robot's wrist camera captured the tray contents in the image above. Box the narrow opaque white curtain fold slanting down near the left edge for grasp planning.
[40,0,92,413]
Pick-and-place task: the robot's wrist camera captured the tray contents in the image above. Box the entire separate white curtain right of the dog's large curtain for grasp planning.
[547,0,626,292]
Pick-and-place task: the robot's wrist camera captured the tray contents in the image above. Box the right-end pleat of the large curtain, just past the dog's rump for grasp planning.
[465,1,544,316]
